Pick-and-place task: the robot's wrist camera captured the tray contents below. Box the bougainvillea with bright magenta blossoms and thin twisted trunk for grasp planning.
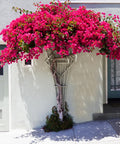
[0,1,120,123]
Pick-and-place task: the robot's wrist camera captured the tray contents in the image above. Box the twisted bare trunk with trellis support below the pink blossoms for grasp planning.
[47,49,75,121]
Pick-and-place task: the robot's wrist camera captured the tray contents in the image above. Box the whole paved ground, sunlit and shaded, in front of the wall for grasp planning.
[0,119,120,144]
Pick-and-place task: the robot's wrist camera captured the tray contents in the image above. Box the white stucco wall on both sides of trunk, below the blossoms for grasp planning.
[12,50,103,128]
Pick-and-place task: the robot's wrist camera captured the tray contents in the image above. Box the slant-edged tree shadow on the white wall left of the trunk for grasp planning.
[17,54,56,128]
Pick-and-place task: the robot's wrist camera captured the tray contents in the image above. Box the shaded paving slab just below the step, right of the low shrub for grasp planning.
[73,121,117,141]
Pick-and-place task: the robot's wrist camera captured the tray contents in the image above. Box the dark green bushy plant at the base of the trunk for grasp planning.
[43,103,73,132]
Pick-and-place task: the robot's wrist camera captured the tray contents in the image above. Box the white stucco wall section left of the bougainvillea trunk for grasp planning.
[10,53,56,129]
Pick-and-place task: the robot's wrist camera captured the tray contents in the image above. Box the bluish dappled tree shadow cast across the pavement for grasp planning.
[14,121,118,144]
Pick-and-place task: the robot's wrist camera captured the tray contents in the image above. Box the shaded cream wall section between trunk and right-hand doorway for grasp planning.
[66,52,103,123]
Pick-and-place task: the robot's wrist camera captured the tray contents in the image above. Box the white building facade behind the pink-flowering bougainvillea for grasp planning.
[0,0,120,131]
